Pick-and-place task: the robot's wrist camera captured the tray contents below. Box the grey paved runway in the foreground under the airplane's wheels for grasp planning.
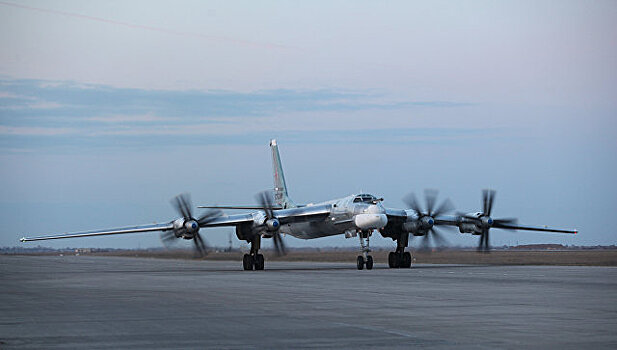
[0,256,617,349]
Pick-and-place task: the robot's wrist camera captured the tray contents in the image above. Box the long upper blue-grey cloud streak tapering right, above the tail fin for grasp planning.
[0,80,469,120]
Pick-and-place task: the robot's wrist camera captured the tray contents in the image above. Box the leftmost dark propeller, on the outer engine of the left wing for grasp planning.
[161,193,222,257]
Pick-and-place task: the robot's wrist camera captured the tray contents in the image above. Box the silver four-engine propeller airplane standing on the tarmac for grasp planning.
[20,139,577,270]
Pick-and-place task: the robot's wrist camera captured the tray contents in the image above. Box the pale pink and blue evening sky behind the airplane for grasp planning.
[0,1,617,248]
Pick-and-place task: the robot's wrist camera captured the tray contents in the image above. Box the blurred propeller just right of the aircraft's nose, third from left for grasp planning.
[403,189,454,250]
